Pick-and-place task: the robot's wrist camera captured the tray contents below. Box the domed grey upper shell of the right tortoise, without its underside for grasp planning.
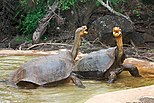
[73,47,116,72]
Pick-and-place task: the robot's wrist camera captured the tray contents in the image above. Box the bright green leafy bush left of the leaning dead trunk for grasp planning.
[17,0,46,37]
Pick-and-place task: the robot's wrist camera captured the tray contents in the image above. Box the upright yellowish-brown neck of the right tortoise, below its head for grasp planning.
[116,36,123,64]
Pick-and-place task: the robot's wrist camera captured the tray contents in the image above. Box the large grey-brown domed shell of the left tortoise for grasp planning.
[11,51,74,87]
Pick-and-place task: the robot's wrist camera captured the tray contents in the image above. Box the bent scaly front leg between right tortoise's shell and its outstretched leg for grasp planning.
[107,68,123,83]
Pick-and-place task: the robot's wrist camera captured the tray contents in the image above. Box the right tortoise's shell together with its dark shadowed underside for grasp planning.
[73,47,119,80]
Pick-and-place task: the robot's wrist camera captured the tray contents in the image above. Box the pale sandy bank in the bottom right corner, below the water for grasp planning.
[85,85,154,103]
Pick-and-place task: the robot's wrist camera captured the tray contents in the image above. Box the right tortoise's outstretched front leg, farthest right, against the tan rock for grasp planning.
[121,64,141,77]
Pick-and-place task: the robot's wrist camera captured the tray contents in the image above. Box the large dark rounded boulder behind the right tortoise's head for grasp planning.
[87,15,143,45]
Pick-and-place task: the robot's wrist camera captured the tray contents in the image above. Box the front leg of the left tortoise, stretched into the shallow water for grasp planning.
[70,73,85,88]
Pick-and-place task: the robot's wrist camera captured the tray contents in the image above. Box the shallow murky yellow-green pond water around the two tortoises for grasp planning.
[0,56,154,103]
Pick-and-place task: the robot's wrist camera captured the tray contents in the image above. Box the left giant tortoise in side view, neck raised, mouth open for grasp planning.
[10,26,88,89]
